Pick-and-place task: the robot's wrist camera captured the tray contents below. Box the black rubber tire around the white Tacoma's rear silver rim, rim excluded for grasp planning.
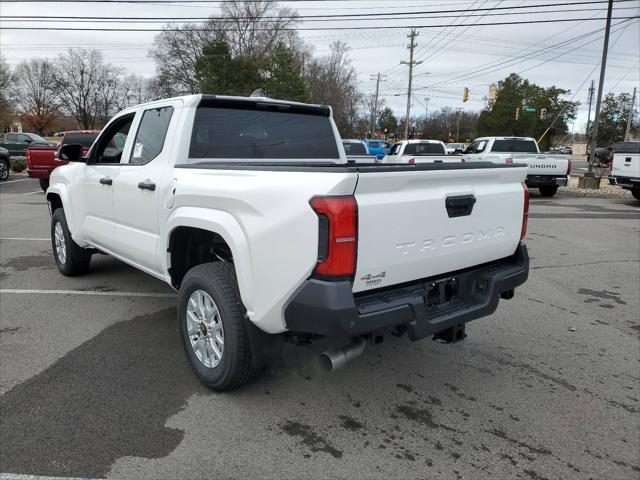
[178,262,256,391]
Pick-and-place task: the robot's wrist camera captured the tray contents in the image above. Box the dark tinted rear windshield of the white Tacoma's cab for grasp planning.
[188,106,340,163]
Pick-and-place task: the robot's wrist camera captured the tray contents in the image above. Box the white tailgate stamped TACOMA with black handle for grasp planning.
[353,164,526,292]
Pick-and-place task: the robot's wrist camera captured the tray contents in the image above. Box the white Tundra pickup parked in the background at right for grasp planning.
[463,137,571,197]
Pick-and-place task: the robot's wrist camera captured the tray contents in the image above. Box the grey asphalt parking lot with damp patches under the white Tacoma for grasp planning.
[0,177,640,480]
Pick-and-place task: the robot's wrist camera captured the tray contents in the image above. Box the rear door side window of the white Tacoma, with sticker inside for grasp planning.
[129,107,173,164]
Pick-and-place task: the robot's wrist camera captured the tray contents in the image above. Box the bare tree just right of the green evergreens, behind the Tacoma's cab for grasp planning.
[305,41,362,137]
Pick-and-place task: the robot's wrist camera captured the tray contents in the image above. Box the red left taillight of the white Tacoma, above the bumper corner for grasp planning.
[310,195,358,278]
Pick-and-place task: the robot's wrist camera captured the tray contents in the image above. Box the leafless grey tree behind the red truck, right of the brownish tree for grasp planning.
[56,48,106,129]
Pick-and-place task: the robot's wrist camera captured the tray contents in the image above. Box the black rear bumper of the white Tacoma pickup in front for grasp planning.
[285,244,529,340]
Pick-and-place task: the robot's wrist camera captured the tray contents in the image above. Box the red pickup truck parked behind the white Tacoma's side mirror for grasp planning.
[26,130,100,191]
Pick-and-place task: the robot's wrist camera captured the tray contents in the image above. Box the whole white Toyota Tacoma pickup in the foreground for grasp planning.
[46,95,529,390]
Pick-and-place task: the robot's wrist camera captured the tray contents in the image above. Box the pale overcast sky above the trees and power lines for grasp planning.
[0,0,640,131]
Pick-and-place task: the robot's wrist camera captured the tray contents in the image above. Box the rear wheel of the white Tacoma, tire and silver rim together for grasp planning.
[178,262,256,391]
